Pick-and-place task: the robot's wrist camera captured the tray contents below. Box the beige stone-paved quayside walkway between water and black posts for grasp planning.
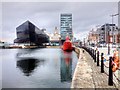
[71,49,118,90]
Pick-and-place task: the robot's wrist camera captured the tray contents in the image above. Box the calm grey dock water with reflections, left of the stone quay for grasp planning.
[1,48,78,88]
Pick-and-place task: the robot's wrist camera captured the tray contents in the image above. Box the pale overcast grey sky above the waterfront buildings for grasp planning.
[0,0,118,43]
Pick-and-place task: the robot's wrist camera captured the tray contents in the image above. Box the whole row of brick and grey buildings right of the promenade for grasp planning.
[88,24,120,46]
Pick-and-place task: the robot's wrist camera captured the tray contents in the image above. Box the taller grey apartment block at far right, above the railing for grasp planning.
[97,24,118,44]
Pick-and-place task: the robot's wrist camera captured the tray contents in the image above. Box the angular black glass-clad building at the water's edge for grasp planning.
[14,21,49,46]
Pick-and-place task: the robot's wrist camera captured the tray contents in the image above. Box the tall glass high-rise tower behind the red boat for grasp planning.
[60,14,73,43]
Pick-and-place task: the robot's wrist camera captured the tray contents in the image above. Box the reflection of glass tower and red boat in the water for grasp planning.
[60,51,72,82]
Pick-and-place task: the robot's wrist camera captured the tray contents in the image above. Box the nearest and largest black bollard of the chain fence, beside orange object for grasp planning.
[108,57,113,86]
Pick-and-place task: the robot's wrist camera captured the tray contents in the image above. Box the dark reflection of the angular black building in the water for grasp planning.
[16,49,45,76]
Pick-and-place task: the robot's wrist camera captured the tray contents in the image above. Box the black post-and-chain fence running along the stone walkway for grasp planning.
[81,47,120,86]
